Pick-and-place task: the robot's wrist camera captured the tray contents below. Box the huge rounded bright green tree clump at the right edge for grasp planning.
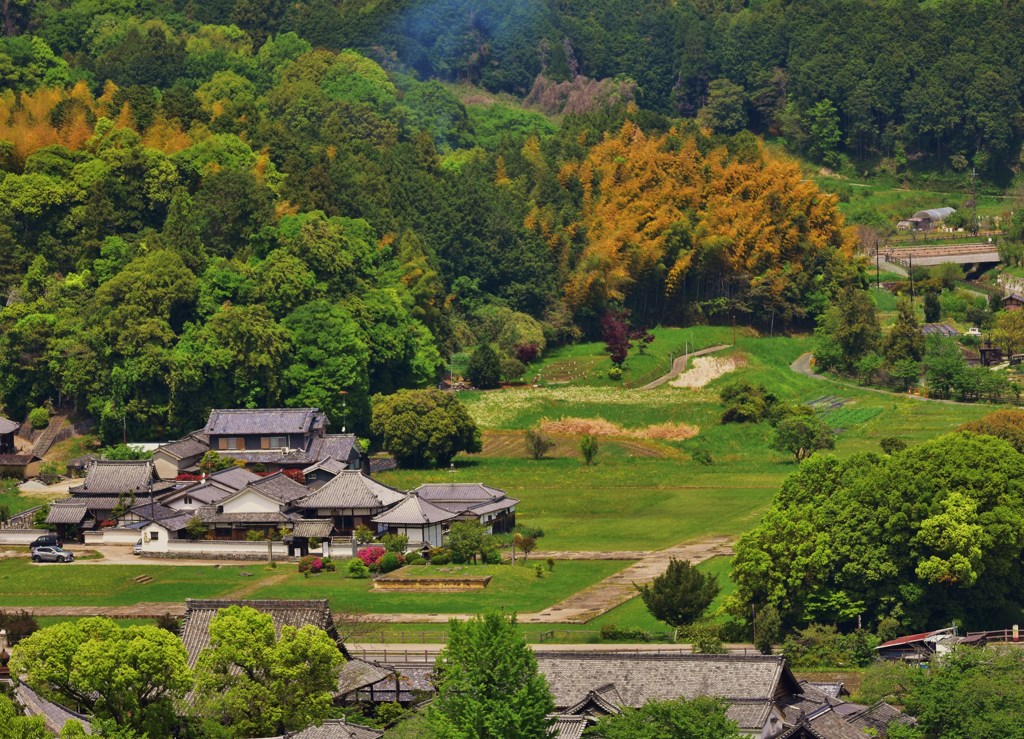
[733,433,1024,628]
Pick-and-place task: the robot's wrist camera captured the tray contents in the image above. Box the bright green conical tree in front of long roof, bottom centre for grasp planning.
[427,613,555,739]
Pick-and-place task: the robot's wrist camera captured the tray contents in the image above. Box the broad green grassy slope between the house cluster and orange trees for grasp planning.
[381,331,990,551]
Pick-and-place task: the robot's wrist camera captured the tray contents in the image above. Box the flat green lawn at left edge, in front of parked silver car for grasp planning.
[0,559,281,608]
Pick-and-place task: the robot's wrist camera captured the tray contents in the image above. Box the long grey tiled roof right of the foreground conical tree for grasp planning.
[537,652,800,729]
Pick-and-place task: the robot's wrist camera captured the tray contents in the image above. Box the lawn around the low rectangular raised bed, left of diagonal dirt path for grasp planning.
[247,561,631,613]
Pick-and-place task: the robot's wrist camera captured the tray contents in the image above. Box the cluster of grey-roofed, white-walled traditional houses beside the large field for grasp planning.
[11,408,519,556]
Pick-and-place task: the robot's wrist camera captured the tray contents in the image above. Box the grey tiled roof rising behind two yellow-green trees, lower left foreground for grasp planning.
[181,598,339,667]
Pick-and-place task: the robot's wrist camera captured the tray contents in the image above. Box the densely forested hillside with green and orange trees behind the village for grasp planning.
[14,0,1007,438]
